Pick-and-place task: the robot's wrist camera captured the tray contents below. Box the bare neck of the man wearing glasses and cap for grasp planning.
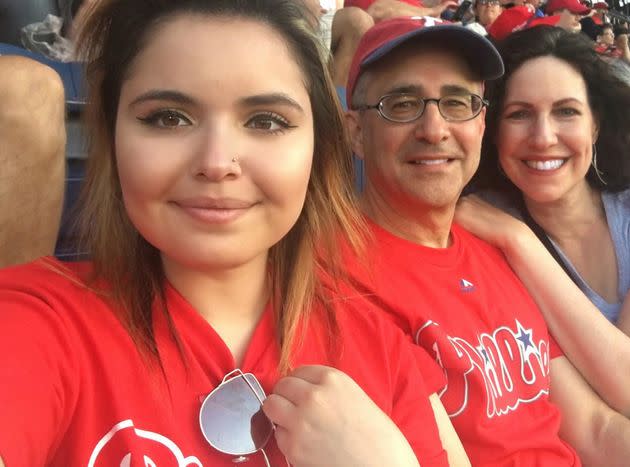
[361,196,455,248]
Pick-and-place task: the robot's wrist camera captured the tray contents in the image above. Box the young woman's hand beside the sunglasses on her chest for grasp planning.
[263,365,418,467]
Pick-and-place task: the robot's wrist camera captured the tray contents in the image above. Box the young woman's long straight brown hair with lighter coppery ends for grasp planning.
[79,0,364,372]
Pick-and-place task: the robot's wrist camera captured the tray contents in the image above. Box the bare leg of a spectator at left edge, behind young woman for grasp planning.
[0,56,66,267]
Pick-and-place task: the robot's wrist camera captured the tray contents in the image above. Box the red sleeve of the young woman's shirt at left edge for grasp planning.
[0,284,79,467]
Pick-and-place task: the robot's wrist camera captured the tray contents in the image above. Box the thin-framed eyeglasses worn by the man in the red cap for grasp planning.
[356,94,489,123]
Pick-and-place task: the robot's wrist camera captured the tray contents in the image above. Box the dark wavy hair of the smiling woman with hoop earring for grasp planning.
[471,26,630,196]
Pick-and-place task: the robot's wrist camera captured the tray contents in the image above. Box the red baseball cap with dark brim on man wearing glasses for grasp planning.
[346,16,504,109]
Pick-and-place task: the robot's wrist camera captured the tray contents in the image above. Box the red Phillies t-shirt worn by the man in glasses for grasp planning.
[348,222,580,467]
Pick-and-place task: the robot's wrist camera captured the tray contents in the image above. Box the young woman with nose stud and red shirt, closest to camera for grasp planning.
[0,0,467,467]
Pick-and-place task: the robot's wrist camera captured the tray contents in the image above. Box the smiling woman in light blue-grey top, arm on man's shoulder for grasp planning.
[459,26,630,416]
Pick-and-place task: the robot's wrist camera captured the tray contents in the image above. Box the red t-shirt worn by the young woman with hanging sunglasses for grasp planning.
[0,260,447,467]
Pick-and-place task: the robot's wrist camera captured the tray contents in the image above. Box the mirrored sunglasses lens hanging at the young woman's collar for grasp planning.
[199,373,273,456]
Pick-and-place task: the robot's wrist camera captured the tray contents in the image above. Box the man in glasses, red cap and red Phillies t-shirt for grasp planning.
[347,18,630,467]
